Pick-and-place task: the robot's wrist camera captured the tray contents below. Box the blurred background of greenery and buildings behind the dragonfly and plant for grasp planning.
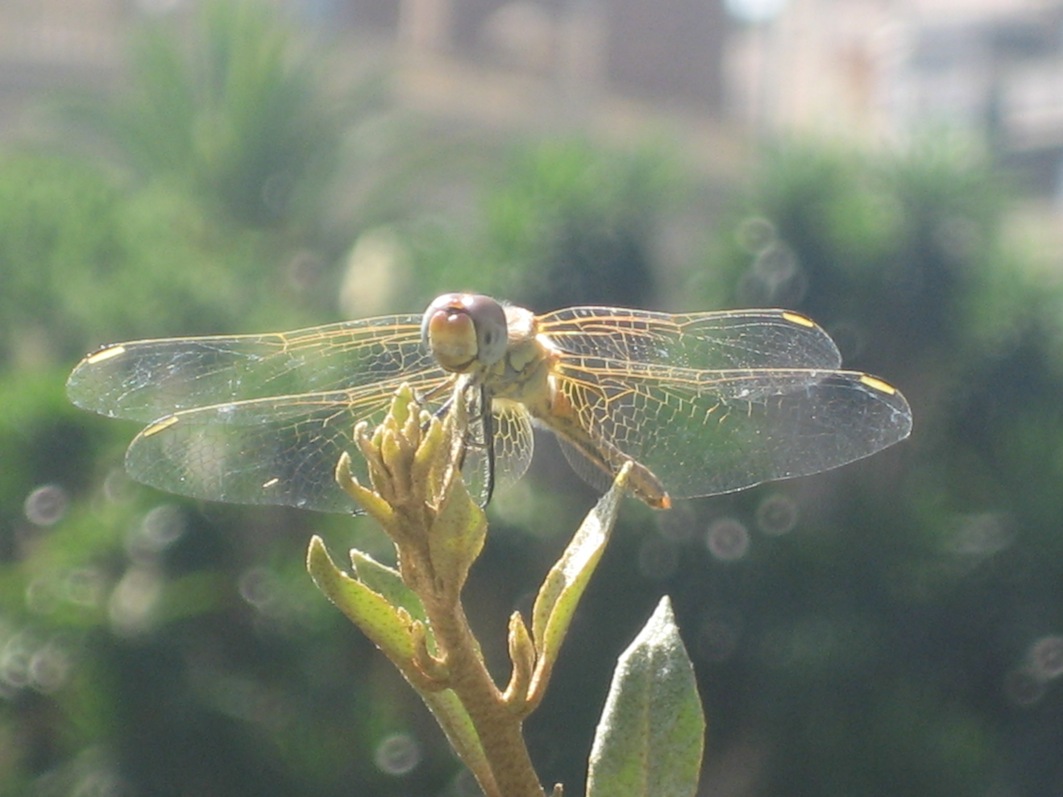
[0,0,1063,797]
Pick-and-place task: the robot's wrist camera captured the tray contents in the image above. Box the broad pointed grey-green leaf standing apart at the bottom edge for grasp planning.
[587,596,705,797]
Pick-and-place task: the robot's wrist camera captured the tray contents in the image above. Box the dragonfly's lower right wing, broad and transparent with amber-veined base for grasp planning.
[558,357,911,497]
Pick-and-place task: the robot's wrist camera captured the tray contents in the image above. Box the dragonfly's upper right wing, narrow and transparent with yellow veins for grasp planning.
[539,307,842,371]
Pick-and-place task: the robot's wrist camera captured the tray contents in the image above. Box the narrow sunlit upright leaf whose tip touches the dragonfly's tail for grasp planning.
[530,464,630,702]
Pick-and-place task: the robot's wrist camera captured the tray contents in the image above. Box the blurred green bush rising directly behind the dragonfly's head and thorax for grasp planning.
[482,139,679,309]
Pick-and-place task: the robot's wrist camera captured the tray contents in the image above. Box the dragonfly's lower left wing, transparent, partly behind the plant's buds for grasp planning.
[125,379,441,512]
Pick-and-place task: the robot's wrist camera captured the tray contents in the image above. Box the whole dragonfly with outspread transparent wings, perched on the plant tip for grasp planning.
[67,293,912,513]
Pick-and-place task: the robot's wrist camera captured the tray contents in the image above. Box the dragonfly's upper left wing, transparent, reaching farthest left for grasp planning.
[67,316,427,422]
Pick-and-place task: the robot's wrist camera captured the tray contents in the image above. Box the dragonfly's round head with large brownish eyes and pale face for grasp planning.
[421,293,509,373]
